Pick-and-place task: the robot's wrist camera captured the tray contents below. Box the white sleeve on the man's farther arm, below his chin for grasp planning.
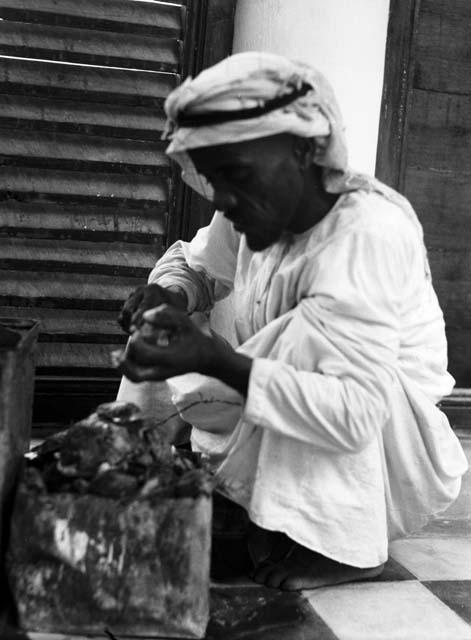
[148,211,240,313]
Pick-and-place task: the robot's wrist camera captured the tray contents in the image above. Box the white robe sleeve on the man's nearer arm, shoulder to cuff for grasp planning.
[244,231,413,452]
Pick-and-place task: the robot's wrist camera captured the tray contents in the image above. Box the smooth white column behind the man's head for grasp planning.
[234,0,389,174]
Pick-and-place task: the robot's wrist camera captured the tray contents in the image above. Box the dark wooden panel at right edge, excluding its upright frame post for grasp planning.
[404,0,471,387]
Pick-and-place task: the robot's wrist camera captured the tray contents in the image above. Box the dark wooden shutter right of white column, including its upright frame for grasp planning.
[377,0,471,388]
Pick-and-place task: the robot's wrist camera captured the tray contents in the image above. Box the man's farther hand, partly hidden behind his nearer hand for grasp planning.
[118,284,187,333]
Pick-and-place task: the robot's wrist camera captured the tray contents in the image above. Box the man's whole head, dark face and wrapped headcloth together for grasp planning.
[159,51,416,250]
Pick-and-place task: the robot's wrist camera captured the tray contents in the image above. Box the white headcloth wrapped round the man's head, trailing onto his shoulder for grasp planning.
[164,51,422,229]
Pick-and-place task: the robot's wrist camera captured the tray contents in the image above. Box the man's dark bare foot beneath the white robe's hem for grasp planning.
[251,533,384,591]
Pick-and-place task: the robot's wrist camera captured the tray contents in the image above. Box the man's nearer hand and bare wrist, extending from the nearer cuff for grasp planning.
[119,304,252,395]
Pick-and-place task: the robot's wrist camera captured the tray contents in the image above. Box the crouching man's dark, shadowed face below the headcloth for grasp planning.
[189,134,303,251]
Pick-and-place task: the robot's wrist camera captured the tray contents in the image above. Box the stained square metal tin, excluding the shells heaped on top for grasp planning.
[8,472,211,638]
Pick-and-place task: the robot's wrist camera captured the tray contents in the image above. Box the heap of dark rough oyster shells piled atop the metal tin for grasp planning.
[23,402,211,498]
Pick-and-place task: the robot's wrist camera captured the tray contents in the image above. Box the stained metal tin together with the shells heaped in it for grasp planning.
[7,402,212,638]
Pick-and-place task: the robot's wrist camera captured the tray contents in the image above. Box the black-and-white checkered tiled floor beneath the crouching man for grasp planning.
[11,431,471,640]
